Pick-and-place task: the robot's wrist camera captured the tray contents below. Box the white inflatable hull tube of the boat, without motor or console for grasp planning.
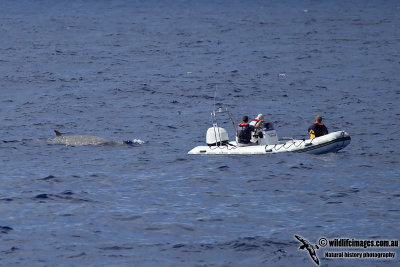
[188,131,351,155]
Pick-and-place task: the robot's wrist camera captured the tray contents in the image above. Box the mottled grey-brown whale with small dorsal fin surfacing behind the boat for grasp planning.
[47,130,144,146]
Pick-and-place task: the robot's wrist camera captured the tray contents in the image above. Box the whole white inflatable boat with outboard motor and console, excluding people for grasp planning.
[188,108,351,155]
